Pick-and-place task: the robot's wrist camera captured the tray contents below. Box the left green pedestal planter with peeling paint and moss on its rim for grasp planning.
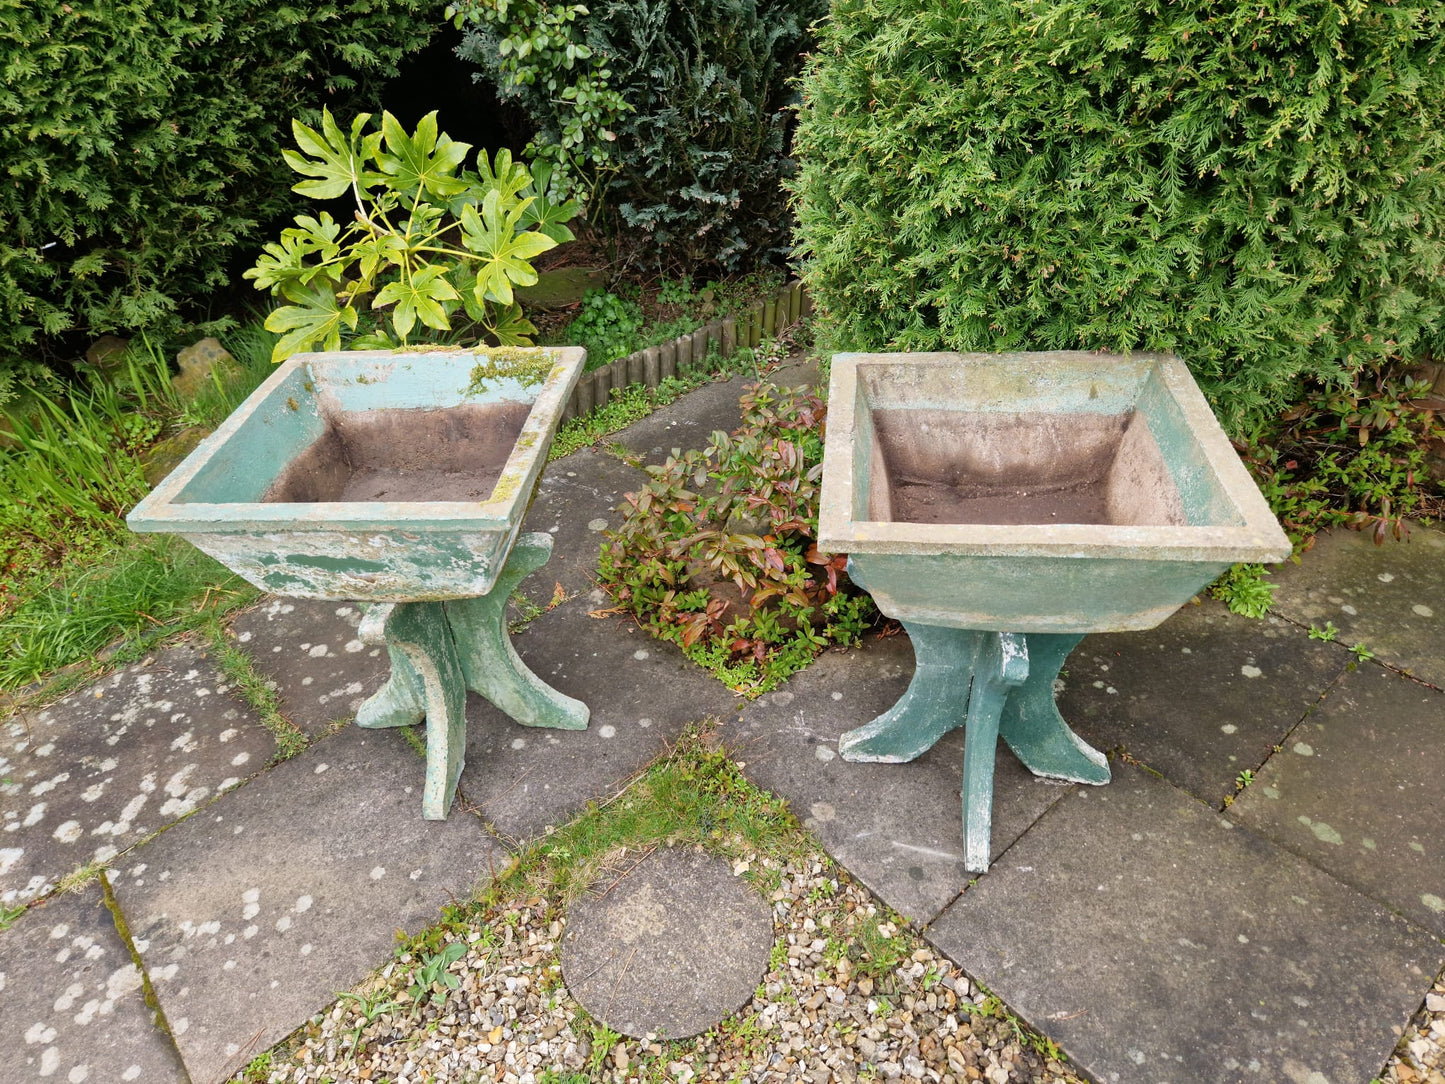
[127,347,588,818]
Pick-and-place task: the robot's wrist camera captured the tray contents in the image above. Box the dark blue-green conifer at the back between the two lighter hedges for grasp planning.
[460,0,827,267]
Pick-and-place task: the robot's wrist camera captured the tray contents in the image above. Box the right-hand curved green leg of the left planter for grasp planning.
[445,533,590,730]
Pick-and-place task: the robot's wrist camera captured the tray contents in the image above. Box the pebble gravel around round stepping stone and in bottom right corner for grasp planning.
[236,856,1445,1084]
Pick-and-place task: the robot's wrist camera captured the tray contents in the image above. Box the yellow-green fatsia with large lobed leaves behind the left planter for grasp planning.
[244,111,578,361]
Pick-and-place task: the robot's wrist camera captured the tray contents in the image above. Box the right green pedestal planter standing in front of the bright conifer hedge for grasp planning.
[819,351,1290,872]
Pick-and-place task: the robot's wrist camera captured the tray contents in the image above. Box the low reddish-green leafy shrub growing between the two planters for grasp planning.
[598,384,871,695]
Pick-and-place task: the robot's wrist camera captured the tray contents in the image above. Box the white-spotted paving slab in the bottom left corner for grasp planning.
[0,882,186,1084]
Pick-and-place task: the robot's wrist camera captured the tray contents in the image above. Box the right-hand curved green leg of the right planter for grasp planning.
[998,633,1110,785]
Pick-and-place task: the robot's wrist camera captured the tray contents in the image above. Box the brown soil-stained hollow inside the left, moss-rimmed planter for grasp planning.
[263,403,532,504]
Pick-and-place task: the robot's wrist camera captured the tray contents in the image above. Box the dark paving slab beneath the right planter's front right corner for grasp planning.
[1058,600,1354,806]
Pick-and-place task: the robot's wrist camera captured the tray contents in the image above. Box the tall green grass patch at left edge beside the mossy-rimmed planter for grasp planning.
[0,324,273,688]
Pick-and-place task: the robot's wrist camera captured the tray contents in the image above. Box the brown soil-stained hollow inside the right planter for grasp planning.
[868,409,1186,526]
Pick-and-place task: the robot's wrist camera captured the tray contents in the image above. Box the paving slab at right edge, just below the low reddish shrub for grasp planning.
[1273,525,1445,688]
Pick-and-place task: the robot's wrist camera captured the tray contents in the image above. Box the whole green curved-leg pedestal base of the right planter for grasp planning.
[838,621,1110,873]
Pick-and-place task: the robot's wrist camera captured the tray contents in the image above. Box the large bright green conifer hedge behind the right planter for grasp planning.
[795,0,1445,432]
